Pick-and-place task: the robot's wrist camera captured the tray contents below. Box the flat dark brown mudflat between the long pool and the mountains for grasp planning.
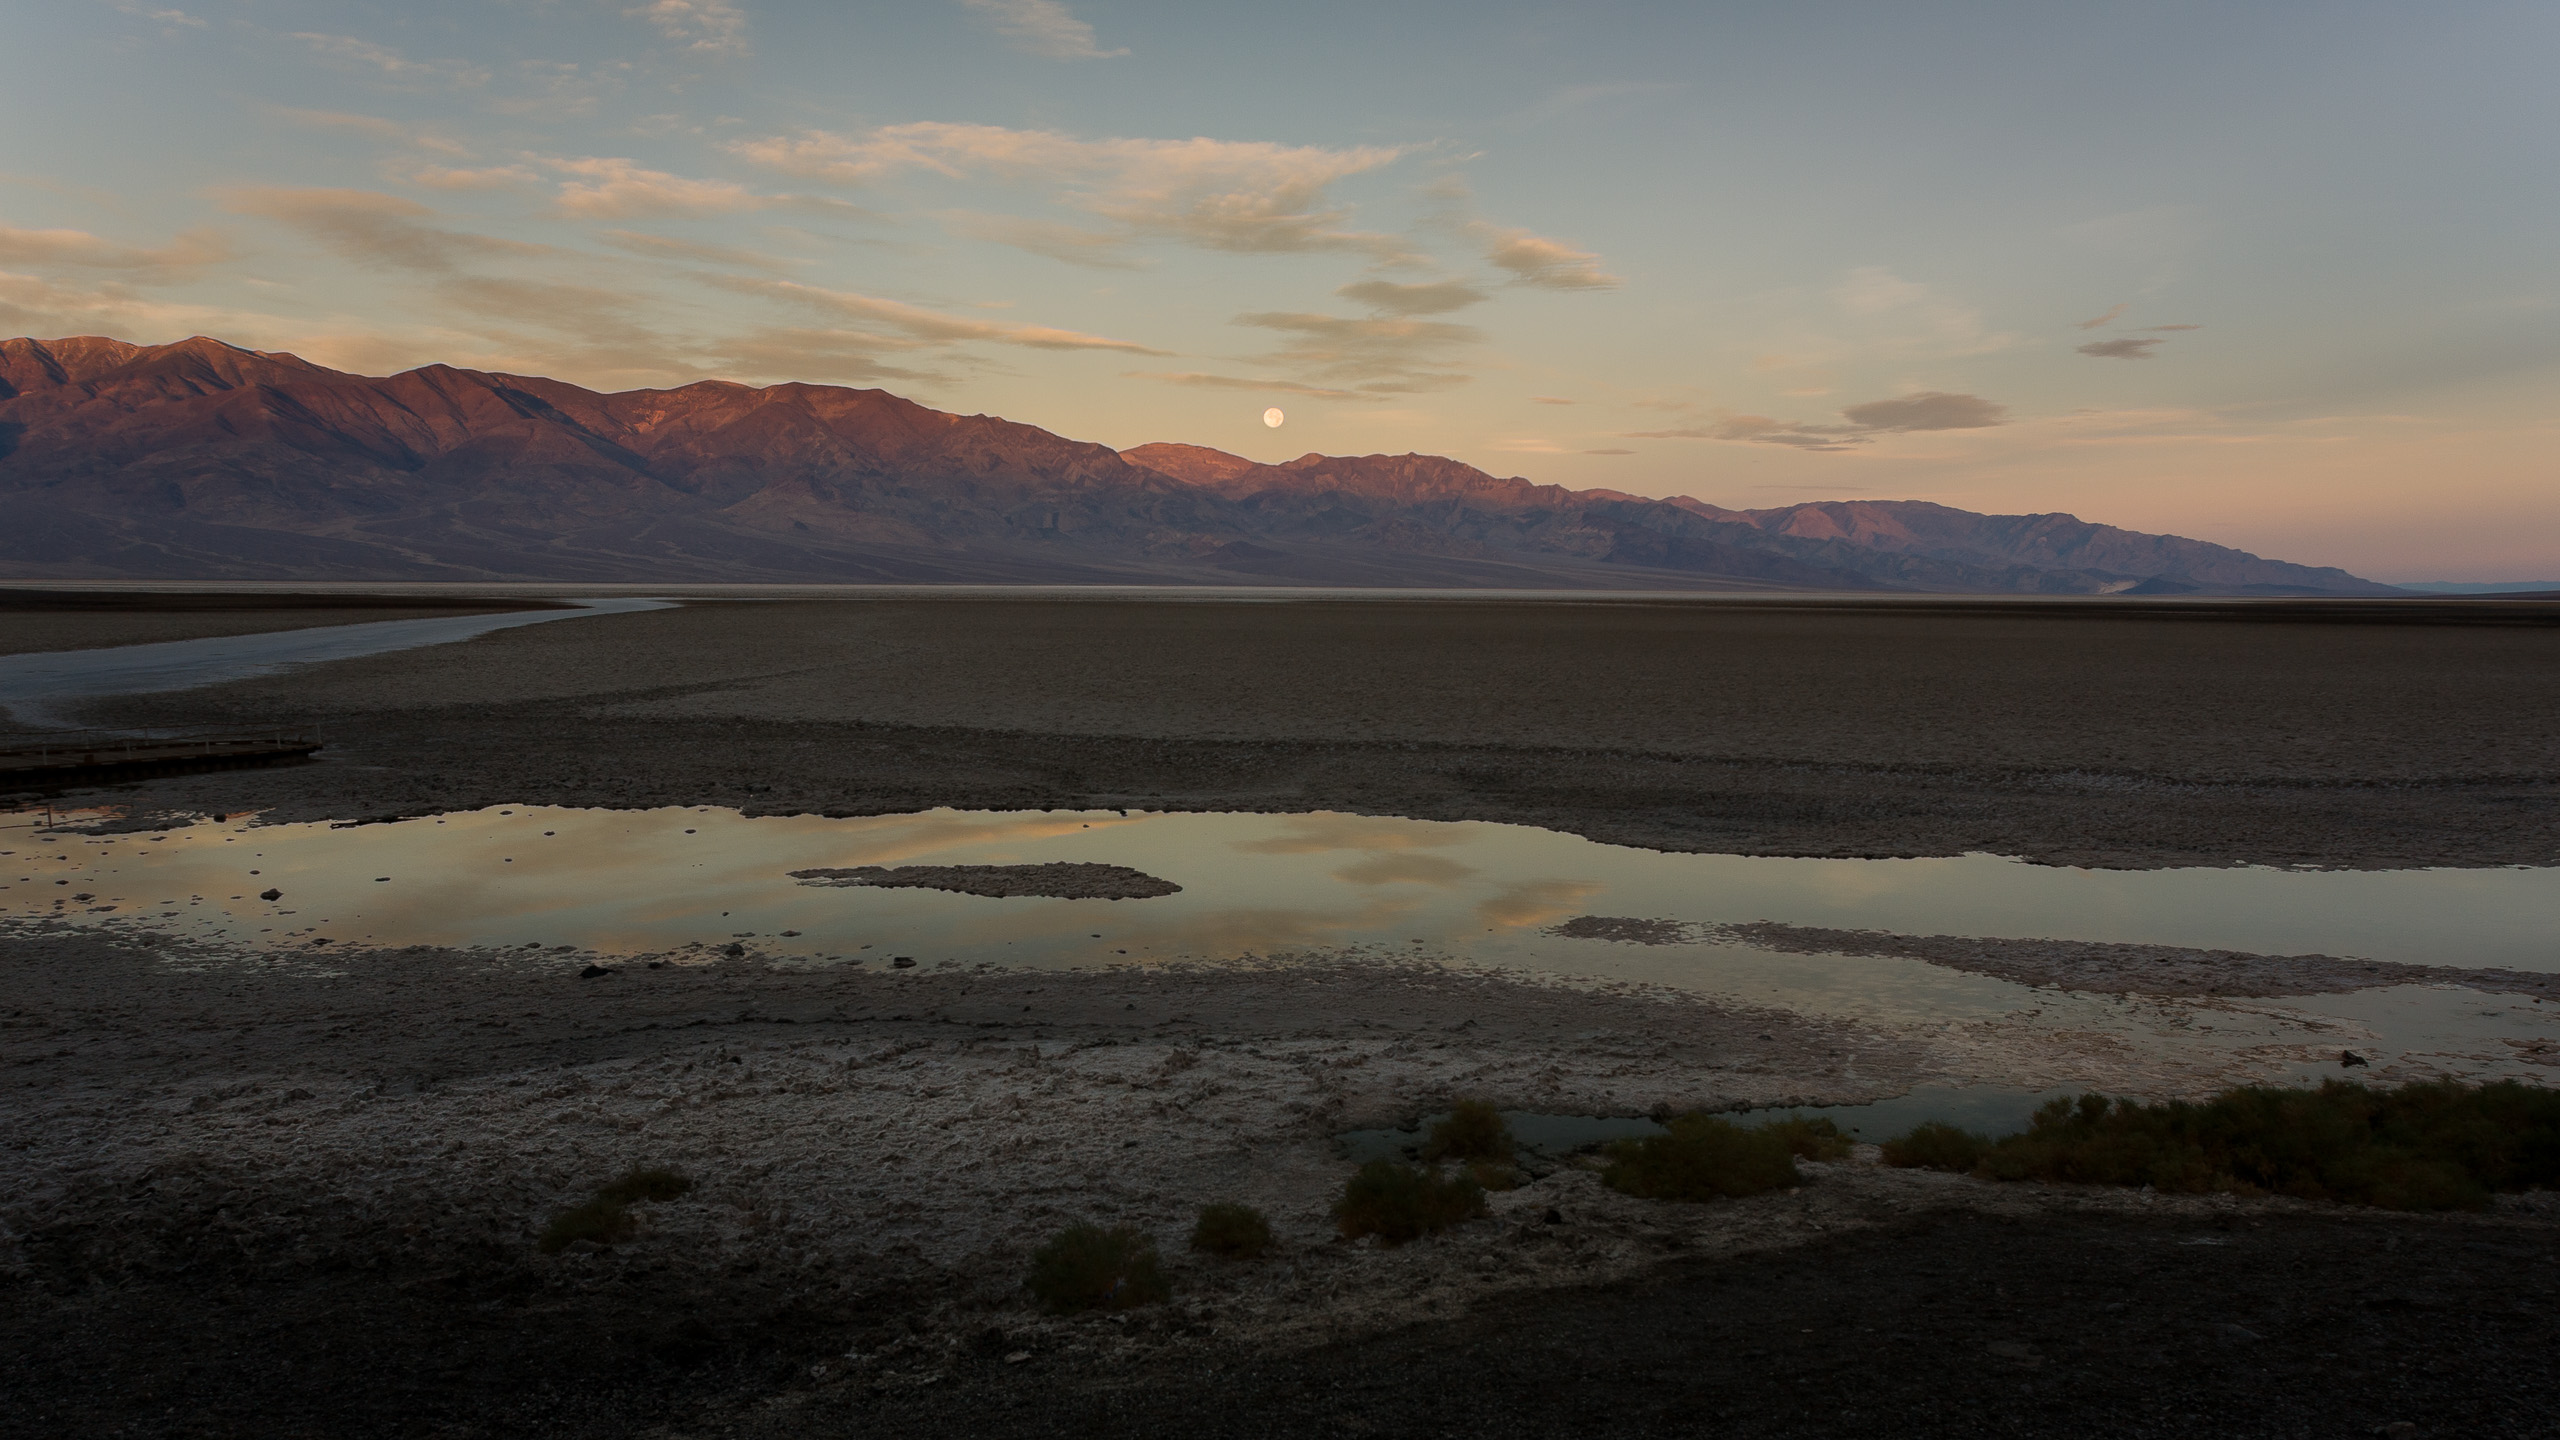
[35,594,2560,869]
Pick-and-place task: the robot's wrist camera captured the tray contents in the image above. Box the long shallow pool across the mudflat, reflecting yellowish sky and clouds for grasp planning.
[0,807,2560,1060]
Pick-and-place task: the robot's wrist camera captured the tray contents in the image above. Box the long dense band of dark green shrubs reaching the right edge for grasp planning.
[1887,1081,2560,1209]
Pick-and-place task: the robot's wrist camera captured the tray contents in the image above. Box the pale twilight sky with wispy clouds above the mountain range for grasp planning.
[0,0,2560,579]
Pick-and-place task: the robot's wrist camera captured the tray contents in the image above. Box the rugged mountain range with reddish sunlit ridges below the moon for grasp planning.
[0,338,2394,594]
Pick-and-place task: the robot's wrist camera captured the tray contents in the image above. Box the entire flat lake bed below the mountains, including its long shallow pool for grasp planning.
[0,592,2560,1435]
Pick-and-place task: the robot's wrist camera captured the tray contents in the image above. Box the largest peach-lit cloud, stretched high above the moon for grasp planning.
[730,120,1411,264]
